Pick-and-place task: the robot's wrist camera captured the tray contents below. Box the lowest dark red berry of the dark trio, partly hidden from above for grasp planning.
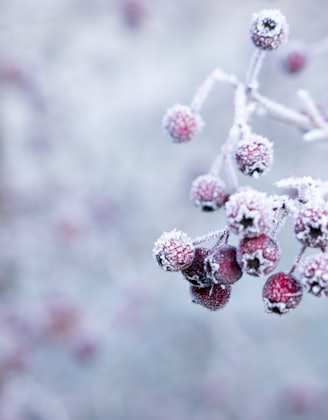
[190,284,231,311]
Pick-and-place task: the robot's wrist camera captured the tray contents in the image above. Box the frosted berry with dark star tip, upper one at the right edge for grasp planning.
[294,204,328,249]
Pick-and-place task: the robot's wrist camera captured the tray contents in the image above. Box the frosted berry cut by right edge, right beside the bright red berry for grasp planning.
[300,254,328,297]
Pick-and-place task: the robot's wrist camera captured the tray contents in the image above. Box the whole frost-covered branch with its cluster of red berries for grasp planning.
[153,9,328,315]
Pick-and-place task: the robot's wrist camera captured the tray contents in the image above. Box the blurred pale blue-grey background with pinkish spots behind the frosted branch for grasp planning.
[0,0,328,420]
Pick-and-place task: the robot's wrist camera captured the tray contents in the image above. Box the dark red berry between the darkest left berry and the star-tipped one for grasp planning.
[205,244,242,284]
